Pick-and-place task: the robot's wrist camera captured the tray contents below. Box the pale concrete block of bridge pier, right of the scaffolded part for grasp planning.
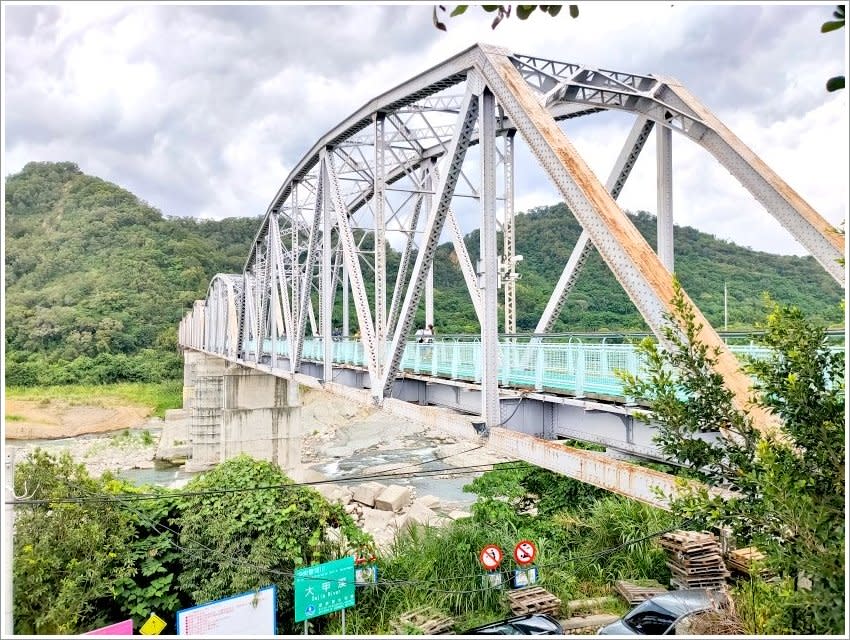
[221,365,303,473]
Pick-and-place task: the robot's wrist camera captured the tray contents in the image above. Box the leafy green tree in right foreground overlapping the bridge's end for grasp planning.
[623,282,846,634]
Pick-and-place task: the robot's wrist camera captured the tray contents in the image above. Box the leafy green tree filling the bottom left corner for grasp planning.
[13,450,135,635]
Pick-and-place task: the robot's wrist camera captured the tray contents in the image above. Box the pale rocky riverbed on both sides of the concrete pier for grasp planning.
[6,384,504,508]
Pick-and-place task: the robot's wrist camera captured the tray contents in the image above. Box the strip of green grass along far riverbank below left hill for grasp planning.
[6,380,183,417]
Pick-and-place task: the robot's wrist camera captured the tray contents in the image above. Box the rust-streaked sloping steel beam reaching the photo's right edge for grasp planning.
[666,79,844,255]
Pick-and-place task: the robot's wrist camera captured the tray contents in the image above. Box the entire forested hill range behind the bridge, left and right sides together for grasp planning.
[5,163,843,385]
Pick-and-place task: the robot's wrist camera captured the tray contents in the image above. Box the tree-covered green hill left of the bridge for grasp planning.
[5,163,259,385]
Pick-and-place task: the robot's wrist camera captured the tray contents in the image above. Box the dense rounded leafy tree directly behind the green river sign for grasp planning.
[177,455,374,633]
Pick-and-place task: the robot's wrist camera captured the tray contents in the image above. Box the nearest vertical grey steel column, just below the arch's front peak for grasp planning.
[478,87,501,427]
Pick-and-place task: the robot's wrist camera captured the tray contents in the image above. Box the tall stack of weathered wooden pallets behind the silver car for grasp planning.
[660,531,729,589]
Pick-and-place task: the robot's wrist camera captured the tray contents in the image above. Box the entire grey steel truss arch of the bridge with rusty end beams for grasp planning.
[180,44,844,438]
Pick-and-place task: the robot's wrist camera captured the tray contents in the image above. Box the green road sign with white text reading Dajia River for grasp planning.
[295,556,354,622]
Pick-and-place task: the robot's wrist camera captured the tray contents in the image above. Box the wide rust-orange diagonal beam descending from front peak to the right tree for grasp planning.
[487,55,780,440]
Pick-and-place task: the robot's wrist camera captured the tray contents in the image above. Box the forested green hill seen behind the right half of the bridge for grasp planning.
[434,204,844,333]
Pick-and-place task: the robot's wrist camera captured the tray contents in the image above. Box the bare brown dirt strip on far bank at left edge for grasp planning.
[3,398,151,440]
